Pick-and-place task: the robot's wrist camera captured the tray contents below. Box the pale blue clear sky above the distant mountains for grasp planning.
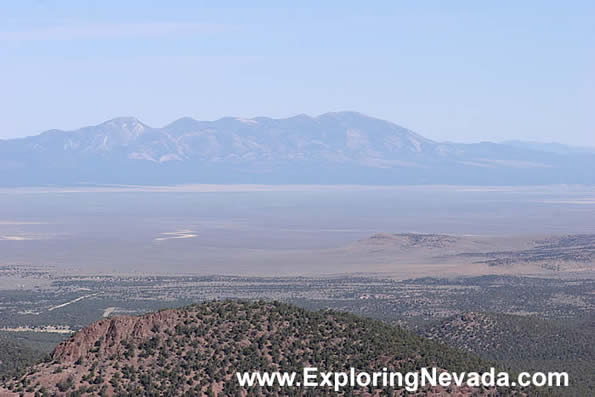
[0,0,595,146]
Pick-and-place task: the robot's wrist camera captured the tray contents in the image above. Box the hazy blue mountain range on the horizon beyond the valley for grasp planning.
[0,112,595,186]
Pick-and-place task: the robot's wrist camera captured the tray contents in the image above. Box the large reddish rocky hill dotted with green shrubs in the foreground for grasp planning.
[0,301,508,396]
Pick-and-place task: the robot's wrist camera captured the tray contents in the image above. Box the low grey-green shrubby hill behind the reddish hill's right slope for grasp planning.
[425,312,595,396]
